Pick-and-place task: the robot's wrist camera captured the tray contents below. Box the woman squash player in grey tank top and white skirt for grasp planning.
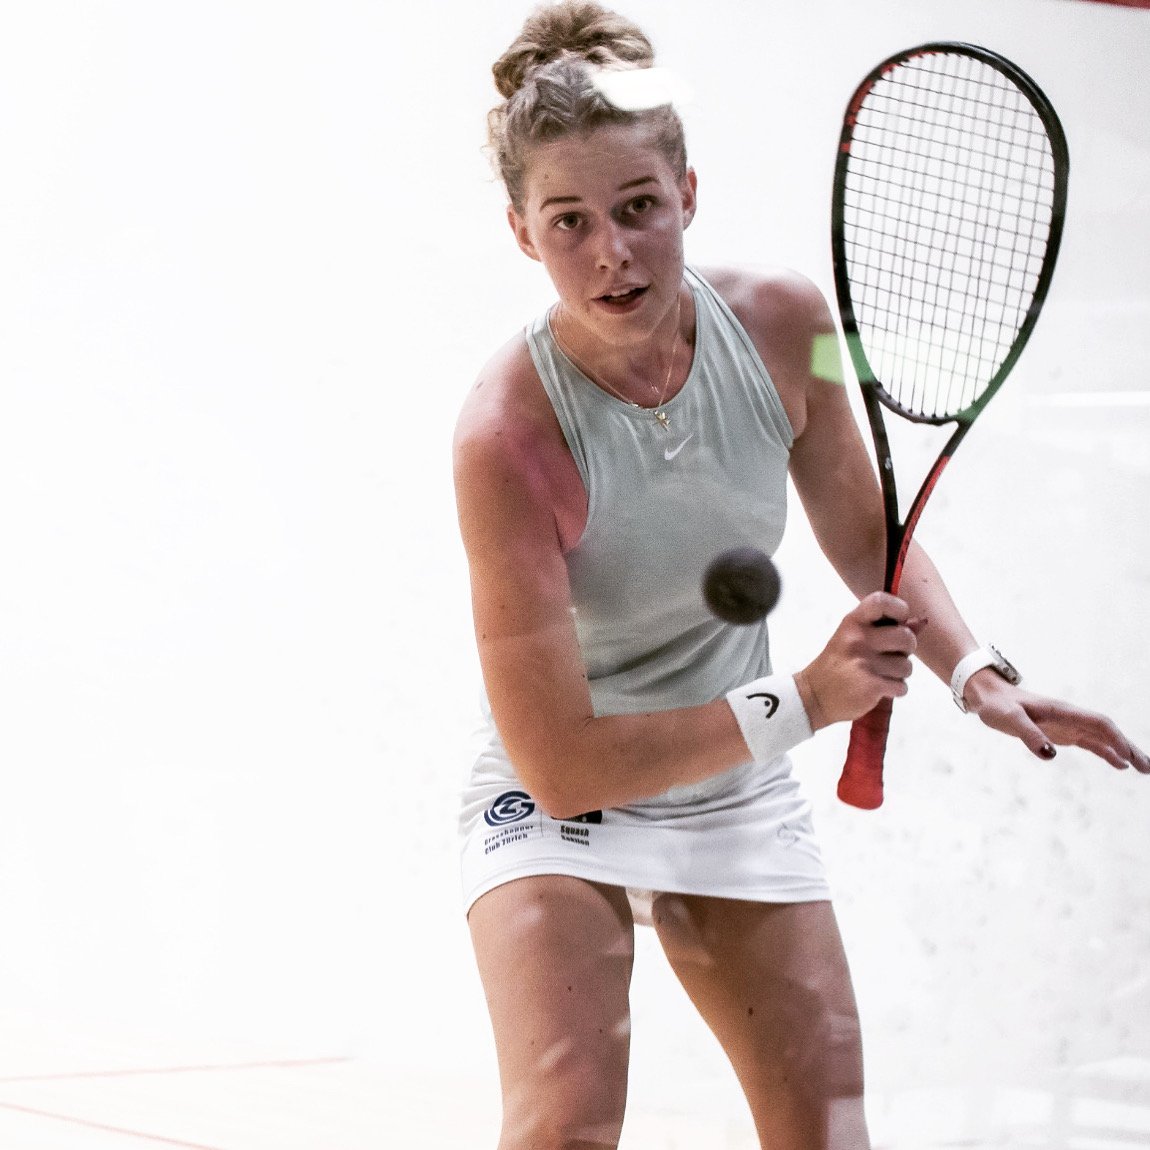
[455,2,1150,1150]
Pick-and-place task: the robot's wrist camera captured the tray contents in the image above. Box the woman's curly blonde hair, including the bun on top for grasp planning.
[488,0,687,210]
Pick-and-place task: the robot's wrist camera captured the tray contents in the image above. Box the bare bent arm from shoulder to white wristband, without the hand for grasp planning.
[454,345,748,818]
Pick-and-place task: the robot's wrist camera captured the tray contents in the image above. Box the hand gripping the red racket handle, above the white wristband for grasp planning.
[795,591,926,730]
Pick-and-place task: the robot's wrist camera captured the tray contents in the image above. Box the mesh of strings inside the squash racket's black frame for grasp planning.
[843,53,1055,419]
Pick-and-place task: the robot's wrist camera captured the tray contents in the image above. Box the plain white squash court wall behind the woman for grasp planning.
[0,0,1150,1131]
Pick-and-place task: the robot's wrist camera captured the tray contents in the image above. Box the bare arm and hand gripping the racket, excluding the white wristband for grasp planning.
[454,328,913,818]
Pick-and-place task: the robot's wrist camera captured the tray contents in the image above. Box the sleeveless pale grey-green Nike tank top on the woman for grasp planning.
[527,268,794,714]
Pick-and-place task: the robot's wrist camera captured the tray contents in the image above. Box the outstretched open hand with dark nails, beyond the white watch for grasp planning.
[964,669,1150,775]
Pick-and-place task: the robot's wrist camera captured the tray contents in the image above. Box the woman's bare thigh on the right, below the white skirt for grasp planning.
[654,895,871,1150]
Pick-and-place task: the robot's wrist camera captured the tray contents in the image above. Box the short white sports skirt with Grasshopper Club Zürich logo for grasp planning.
[460,738,830,922]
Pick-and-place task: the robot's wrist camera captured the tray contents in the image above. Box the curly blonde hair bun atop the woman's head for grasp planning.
[491,0,654,100]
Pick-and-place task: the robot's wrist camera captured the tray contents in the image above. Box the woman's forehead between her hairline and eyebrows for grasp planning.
[524,121,677,208]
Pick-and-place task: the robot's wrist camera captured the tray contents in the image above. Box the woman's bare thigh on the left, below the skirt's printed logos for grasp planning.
[468,875,635,1150]
